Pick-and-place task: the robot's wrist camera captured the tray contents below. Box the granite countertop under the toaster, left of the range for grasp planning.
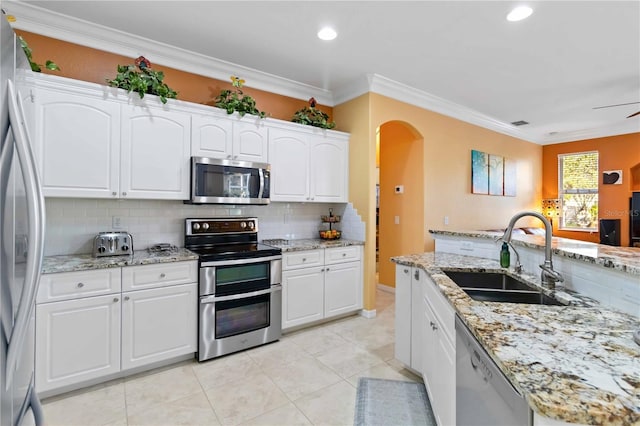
[42,248,198,274]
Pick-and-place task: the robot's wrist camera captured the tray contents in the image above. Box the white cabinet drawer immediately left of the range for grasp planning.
[122,261,198,291]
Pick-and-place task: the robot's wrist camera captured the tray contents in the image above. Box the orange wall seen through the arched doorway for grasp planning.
[378,121,424,287]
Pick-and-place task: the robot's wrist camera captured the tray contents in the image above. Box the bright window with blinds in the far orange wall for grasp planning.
[558,152,598,231]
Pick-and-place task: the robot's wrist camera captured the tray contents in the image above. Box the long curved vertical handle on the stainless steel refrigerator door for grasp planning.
[5,80,45,389]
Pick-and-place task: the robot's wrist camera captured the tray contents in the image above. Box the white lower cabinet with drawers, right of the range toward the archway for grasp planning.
[282,246,362,330]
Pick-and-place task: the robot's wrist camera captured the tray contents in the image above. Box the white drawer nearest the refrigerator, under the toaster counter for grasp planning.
[37,268,121,303]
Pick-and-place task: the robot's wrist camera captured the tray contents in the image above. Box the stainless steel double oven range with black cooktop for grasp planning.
[185,218,282,361]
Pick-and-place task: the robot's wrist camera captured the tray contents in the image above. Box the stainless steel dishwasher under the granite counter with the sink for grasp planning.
[456,315,533,426]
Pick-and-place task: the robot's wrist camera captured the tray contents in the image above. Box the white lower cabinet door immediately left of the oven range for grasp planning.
[122,283,198,370]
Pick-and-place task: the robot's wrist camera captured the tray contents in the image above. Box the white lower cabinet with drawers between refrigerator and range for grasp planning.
[36,261,198,395]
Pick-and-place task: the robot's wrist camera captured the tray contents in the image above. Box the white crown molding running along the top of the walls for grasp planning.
[8,1,640,145]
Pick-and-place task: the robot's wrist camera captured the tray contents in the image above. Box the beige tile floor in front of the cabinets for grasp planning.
[43,290,421,426]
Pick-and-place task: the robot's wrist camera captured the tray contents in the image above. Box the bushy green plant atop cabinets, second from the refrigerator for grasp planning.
[107,56,178,104]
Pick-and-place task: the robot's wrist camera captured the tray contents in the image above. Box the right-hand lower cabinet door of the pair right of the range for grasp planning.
[324,262,362,318]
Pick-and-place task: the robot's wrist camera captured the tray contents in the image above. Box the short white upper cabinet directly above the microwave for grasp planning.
[191,113,268,163]
